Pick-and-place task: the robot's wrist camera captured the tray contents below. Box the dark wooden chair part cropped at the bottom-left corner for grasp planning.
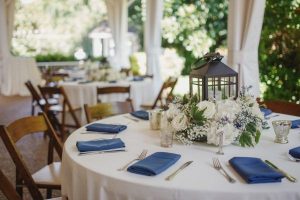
[0,169,21,200]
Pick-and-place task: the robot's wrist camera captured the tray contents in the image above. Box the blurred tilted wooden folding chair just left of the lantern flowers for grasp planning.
[141,77,178,110]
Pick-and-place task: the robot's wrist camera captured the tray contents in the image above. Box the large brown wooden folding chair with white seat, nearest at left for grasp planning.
[0,113,62,199]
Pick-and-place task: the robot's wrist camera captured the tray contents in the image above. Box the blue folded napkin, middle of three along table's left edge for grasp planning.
[85,123,127,133]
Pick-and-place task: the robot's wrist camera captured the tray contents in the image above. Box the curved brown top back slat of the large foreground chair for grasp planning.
[7,116,48,142]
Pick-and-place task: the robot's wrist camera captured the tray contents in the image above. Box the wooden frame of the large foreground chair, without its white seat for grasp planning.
[0,113,62,199]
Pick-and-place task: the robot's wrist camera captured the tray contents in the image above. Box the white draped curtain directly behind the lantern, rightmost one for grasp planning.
[228,0,265,97]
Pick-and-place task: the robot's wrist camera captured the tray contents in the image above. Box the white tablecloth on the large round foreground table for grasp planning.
[62,114,300,200]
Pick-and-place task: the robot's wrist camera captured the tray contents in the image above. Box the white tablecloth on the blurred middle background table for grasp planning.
[60,79,157,122]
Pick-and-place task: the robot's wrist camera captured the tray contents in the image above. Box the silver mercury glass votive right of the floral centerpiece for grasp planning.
[272,120,292,144]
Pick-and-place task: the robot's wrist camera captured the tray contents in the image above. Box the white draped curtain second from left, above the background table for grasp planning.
[105,0,129,69]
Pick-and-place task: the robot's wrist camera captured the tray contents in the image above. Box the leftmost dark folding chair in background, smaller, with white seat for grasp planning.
[25,80,58,115]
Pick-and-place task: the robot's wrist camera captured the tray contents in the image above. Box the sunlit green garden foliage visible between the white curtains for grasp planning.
[12,0,300,103]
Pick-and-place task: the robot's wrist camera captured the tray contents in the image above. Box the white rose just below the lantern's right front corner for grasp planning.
[215,99,240,121]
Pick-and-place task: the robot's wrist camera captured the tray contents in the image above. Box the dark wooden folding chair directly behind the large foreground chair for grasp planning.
[38,86,81,141]
